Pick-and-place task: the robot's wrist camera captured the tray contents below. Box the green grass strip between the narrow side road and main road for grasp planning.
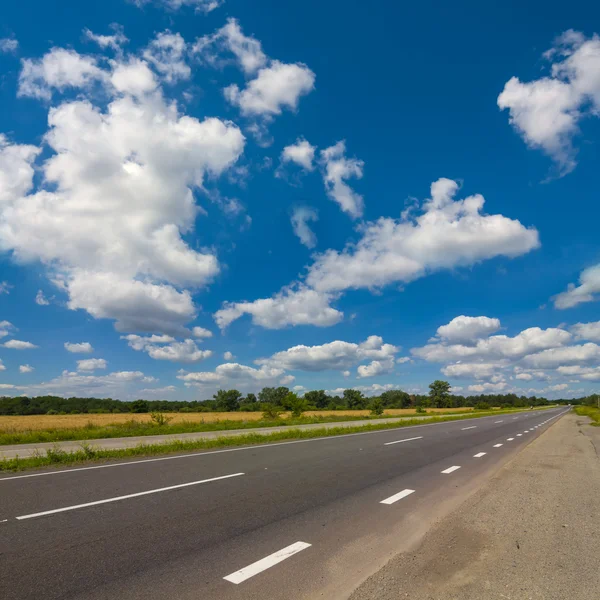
[0,410,552,472]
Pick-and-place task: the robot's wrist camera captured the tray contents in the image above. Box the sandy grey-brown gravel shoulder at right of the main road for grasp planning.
[351,413,600,600]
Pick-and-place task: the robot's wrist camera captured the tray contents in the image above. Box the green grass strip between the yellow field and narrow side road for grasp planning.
[0,409,478,446]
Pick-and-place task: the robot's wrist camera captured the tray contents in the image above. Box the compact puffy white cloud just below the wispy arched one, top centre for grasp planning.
[224,60,315,118]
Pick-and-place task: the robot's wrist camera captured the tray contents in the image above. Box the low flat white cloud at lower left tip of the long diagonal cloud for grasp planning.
[214,285,344,329]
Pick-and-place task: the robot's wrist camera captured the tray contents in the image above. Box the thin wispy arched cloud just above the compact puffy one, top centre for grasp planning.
[192,18,268,75]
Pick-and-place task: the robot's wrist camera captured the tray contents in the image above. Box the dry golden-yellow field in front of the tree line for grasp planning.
[0,407,473,432]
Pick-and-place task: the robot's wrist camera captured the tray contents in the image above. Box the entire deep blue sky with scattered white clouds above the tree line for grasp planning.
[0,0,600,399]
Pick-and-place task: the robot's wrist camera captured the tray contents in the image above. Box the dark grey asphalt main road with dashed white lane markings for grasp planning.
[0,408,565,600]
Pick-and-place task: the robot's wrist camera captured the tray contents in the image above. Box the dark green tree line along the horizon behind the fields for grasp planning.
[0,380,597,415]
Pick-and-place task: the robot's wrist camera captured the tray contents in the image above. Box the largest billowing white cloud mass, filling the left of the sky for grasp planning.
[0,48,245,335]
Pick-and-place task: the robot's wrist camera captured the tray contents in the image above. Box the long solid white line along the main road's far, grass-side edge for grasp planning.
[0,415,560,483]
